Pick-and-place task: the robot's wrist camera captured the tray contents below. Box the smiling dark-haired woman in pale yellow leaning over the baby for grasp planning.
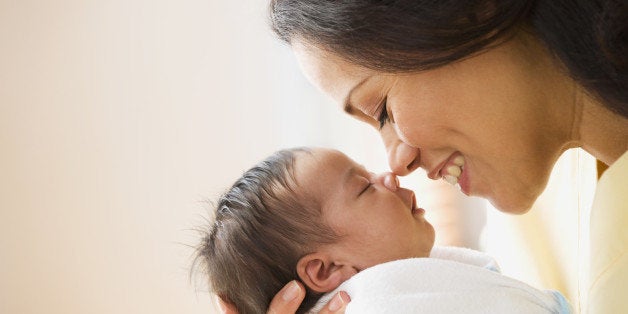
[220,0,628,313]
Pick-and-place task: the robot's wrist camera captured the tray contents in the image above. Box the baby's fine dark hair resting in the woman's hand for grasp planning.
[194,148,337,314]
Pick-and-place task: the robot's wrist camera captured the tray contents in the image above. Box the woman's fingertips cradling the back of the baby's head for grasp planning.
[216,280,351,314]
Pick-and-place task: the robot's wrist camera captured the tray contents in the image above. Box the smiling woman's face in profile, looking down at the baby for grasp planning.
[292,40,572,213]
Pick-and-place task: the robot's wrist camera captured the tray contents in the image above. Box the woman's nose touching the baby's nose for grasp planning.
[380,125,421,176]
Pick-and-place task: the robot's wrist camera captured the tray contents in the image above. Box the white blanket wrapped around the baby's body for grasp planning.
[311,248,571,314]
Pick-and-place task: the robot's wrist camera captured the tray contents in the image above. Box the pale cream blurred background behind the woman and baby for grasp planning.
[0,0,594,314]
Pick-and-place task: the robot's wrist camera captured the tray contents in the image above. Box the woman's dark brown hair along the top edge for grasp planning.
[270,0,628,117]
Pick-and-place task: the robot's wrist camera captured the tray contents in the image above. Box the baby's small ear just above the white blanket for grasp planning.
[297,252,357,293]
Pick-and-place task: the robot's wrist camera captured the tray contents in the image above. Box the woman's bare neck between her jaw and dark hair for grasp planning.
[515,32,628,165]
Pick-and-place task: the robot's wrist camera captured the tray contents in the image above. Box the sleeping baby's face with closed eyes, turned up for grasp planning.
[295,149,434,270]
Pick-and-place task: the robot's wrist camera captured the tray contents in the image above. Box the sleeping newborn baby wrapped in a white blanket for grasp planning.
[196,148,570,314]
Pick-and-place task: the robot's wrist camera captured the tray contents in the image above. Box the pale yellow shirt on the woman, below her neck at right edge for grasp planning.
[581,152,628,314]
